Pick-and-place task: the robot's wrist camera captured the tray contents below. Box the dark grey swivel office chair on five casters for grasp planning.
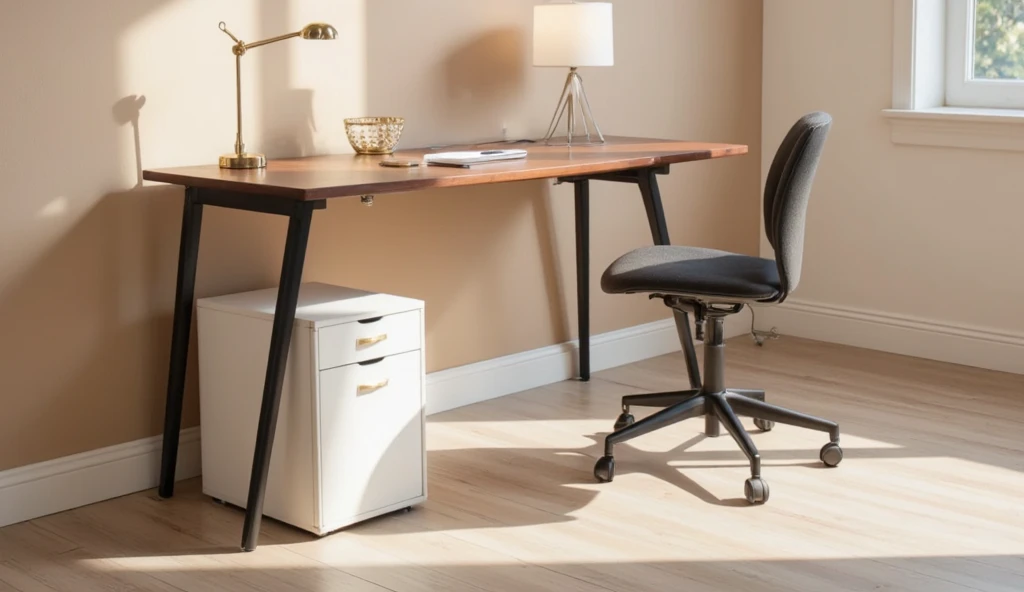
[594,113,843,504]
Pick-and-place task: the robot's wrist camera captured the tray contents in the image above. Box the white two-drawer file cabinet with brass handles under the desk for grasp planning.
[197,284,427,535]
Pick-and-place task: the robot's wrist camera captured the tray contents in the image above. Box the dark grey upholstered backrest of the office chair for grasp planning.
[764,112,831,302]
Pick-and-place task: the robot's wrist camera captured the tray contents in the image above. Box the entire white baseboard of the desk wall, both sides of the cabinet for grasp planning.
[0,313,750,527]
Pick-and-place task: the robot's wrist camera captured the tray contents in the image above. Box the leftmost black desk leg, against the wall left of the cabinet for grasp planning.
[159,187,203,498]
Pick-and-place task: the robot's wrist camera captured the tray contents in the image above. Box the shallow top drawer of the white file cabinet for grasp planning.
[318,310,423,370]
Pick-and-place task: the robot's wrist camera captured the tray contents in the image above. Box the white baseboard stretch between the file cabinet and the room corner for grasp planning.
[427,309,751,415]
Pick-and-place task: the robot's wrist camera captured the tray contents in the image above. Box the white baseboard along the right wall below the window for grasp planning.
[756,300,1024,374]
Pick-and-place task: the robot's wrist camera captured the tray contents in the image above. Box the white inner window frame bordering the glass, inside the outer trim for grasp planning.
[945,0,1024,109]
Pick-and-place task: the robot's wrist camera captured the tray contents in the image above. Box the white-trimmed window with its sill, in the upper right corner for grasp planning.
[883,0,1024,152]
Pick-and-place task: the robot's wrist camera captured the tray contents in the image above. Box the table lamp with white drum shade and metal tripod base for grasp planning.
[534,2,615,145]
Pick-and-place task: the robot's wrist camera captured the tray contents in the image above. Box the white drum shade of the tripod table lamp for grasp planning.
[534,2,615,68]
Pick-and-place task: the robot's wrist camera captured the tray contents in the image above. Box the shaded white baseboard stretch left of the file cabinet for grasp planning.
[0,427,202,526]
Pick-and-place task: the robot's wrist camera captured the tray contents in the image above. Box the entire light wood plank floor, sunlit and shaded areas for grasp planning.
[0,338,1024,592]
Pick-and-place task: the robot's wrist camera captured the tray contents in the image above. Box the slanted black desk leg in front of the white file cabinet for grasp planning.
[242,202,315,551]
